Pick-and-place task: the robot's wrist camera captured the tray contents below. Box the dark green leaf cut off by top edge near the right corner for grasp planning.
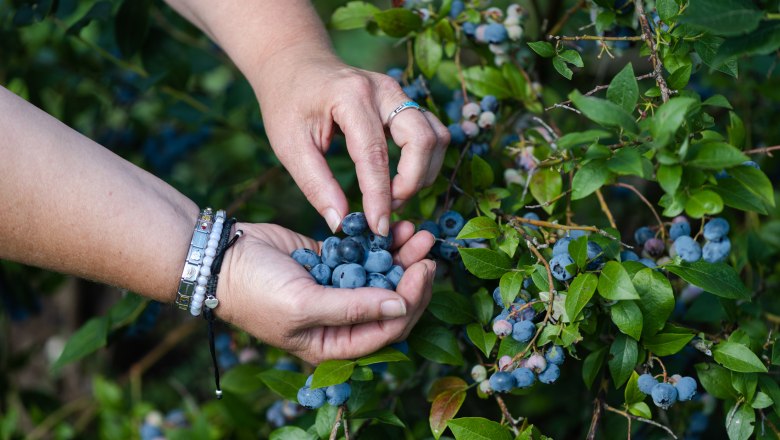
[680,0,763,36]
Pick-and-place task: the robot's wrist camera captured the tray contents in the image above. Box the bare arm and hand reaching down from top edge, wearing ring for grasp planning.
[167,0,450,235]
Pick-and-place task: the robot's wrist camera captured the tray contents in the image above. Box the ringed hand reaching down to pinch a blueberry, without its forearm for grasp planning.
[253,46,450,235]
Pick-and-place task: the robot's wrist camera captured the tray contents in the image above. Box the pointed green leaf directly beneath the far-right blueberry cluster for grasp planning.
[665,261,750,299]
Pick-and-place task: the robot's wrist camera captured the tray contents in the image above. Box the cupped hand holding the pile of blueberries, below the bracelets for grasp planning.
[216,222,436,364]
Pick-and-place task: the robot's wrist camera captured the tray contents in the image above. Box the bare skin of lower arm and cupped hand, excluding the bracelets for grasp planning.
[0,87,435,363]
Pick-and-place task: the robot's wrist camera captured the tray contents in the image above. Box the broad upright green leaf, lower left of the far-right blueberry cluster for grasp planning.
[632,267,674,339]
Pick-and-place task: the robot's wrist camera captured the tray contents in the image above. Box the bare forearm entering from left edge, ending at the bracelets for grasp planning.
[0,87,198,301]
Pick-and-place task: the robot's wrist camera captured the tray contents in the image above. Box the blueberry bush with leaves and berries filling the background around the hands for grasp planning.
[0,0,780,440]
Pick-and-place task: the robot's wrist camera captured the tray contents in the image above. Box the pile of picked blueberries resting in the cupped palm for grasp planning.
[291,212,404,290]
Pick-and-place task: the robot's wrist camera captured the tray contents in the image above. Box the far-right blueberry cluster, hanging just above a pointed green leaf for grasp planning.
[620,216,731,267]
